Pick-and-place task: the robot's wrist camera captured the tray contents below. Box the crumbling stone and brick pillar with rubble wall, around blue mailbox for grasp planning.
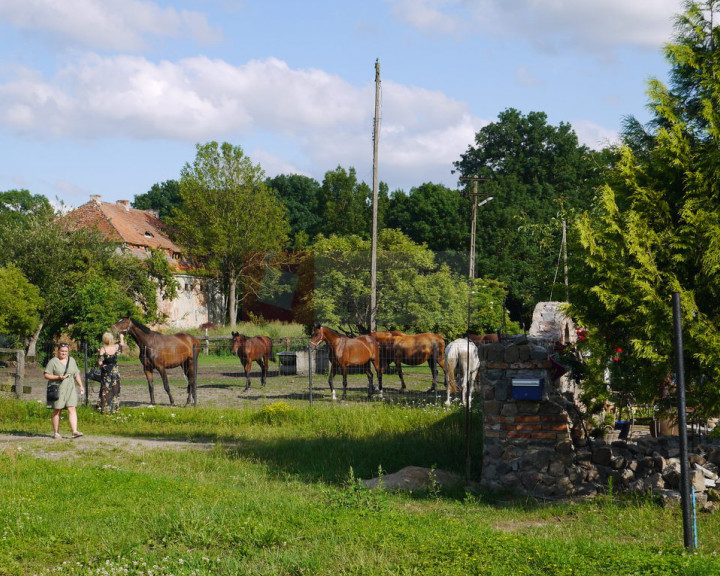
[478,337,720,508]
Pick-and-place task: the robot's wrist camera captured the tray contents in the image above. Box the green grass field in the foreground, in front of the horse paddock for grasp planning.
[0,399,720,576]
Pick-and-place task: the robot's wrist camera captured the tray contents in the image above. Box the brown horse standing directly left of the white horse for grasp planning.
[370,330,447,392]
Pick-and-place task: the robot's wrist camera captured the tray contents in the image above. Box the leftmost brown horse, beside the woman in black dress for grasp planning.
[113,317,200,406]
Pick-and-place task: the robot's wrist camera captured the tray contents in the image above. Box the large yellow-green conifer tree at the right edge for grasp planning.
[572,1,720,413]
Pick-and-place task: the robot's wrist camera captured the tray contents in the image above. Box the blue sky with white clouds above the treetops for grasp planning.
[0,0,682,207]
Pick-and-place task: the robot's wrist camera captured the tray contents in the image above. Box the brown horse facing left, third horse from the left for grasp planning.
[310,325,382,400]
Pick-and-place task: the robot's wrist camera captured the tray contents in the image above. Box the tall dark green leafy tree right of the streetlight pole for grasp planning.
[455,108,606,326]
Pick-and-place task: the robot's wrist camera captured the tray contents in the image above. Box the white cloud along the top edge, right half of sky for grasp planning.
[386,0,682,53]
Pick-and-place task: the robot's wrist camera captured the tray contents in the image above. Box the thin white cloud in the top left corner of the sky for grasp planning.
[0,0,220,51]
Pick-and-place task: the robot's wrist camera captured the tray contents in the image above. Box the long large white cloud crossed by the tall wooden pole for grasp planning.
[0,55,483,186]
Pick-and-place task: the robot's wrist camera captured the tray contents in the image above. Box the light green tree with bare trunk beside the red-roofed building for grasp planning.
[170,142,288,327]
